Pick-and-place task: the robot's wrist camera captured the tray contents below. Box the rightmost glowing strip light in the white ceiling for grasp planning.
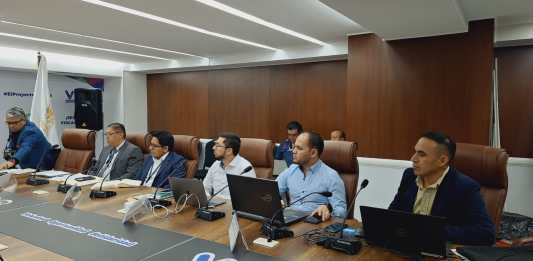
[196,0,327,46]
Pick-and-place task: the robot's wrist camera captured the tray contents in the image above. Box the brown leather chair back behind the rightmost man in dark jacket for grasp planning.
[452,143,509,231]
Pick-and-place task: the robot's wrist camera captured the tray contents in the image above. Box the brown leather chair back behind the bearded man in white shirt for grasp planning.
[239,138,274,179]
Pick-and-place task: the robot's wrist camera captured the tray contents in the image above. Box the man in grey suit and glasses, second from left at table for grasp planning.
[89,123,143,180]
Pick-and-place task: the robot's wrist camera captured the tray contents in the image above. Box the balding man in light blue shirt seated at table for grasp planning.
[277,132,346,221]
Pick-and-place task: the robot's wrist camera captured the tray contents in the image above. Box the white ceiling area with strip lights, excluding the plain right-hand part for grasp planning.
[0,0,364,63]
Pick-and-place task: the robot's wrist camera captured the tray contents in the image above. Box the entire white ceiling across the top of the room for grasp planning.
[0,0,533,63]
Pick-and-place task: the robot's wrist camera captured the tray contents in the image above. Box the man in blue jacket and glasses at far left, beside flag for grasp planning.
[0,107,51,169]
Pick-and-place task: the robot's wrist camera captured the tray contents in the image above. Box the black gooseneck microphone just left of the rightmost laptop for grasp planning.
[318,179,368,255]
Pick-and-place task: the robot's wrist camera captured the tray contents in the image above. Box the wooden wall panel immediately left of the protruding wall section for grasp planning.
[270,61,346,142]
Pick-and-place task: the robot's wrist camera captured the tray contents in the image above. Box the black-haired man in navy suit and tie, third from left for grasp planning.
[135,131,186,188]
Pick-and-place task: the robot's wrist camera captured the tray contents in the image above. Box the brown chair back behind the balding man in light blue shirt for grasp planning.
[320,140,359,218]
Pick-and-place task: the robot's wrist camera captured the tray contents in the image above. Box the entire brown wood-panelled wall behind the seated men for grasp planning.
[148,20,494,159]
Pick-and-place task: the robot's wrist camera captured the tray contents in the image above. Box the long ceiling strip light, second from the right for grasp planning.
[82,0,278,51]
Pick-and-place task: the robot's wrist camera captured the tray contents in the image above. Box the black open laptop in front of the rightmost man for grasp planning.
[361,206,448,258]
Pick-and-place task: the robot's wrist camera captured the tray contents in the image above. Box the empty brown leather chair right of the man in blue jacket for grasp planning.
[54,129,96,173]
